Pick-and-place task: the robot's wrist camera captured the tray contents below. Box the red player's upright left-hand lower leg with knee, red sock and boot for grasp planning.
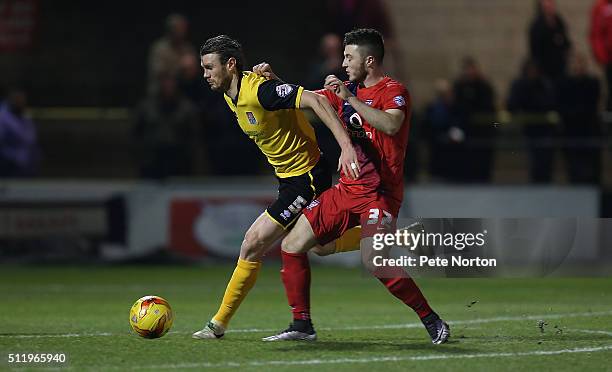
[262,215,317,341]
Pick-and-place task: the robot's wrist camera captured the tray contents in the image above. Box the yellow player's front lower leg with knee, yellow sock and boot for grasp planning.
[193,213,287,339]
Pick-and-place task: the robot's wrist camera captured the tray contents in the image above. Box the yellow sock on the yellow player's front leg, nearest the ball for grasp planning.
[213,258,261,327]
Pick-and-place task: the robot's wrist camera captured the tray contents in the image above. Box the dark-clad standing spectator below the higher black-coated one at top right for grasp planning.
[507,59,555,182]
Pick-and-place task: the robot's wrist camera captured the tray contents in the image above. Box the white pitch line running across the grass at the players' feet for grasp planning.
[0,310,612,338]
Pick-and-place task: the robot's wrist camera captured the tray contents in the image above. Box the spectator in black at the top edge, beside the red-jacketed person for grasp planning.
[529,0,571,84]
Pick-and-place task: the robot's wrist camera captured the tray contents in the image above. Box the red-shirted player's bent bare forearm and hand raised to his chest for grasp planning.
[325,75,406,136]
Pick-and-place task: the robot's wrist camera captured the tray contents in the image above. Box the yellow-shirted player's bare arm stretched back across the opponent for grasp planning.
[300,90,360,179]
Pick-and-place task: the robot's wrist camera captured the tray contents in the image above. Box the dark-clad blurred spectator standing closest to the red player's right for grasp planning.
[423,79,468,181]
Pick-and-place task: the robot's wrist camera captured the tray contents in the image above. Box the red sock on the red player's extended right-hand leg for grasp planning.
[375,267,432,319]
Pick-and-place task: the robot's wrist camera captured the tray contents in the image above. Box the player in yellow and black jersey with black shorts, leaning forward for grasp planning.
[193,35,361,339]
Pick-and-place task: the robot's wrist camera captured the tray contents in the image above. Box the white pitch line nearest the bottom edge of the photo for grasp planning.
[131,345,612,369]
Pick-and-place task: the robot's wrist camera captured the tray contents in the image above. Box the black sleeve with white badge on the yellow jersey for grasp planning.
[257,80,304,111]
